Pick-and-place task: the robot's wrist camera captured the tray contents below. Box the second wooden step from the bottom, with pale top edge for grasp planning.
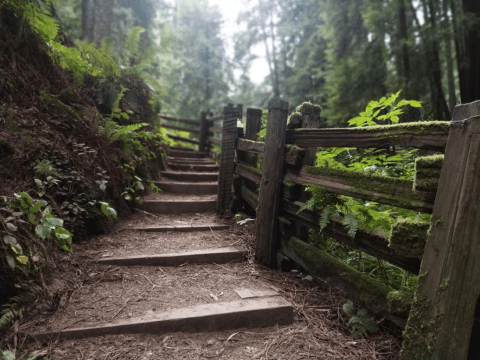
[98,247,247,266]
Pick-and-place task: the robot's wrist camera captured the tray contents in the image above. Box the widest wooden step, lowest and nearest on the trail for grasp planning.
[34,296,293,340]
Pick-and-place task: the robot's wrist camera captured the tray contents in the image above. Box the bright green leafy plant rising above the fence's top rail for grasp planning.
[348,90,422,127]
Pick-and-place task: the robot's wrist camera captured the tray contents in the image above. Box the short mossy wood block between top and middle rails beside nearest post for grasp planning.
[414,155,444,192]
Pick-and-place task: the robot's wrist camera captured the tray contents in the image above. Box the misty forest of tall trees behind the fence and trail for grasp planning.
[51,0,480,126]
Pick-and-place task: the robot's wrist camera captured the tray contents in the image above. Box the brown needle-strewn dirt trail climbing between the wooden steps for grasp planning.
[19,148,399,360]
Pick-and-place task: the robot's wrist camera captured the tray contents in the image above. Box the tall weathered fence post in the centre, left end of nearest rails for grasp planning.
[255,99,288,267]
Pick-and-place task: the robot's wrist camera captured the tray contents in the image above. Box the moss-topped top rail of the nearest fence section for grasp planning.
[286,121,450,151]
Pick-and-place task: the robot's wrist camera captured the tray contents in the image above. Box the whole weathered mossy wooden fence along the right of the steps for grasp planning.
[161,100,480,359]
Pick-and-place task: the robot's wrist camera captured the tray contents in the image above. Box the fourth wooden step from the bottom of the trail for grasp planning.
[137,200,217,214]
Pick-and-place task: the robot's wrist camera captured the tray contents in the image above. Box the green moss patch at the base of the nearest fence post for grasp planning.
[400,292,443,360]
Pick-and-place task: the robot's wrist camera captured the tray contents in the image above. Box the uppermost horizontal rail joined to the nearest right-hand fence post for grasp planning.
[286,125,448,151]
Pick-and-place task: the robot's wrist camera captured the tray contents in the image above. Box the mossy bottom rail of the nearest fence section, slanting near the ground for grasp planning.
[282,237,410,327]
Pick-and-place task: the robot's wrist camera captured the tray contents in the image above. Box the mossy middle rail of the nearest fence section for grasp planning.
[285,168,435,213]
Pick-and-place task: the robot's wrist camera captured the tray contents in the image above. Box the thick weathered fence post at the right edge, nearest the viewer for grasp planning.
[401,101,480,359]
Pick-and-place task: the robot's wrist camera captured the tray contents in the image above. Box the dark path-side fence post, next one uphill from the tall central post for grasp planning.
[217,104,238,213]
